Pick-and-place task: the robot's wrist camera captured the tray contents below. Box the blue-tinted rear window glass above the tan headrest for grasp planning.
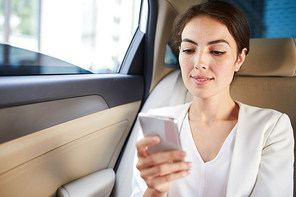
[224,0,296,38]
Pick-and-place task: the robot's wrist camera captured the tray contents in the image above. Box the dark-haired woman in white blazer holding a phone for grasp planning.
[132,2,294,197]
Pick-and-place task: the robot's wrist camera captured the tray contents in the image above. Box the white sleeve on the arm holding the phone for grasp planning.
[131,130,148,197]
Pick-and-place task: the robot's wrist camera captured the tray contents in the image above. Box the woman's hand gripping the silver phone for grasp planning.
[136,136,192,196]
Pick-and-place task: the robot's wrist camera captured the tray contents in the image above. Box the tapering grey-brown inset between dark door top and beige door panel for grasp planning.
[0,95,108,143]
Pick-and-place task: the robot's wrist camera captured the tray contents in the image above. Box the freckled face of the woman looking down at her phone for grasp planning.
[179,16,246,98]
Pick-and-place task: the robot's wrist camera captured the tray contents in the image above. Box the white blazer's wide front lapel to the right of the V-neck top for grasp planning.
[226,102,265,197]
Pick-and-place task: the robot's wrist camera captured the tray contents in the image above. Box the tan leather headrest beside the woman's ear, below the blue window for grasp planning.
[237,38,296,77]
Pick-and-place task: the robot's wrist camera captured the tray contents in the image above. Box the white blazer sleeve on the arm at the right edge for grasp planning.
[251,114,294,197]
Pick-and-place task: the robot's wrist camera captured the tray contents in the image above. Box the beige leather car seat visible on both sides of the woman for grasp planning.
[112,38,296,196]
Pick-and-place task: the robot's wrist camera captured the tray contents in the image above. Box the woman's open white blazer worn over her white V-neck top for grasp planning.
[134,102,294,197]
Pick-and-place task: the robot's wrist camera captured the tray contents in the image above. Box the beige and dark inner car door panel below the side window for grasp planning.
[0,74,144,196]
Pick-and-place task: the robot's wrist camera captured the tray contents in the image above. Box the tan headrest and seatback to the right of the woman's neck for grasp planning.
[231,38,296,130]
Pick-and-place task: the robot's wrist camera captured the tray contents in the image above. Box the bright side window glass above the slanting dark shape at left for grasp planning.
[0,0,141,74]
